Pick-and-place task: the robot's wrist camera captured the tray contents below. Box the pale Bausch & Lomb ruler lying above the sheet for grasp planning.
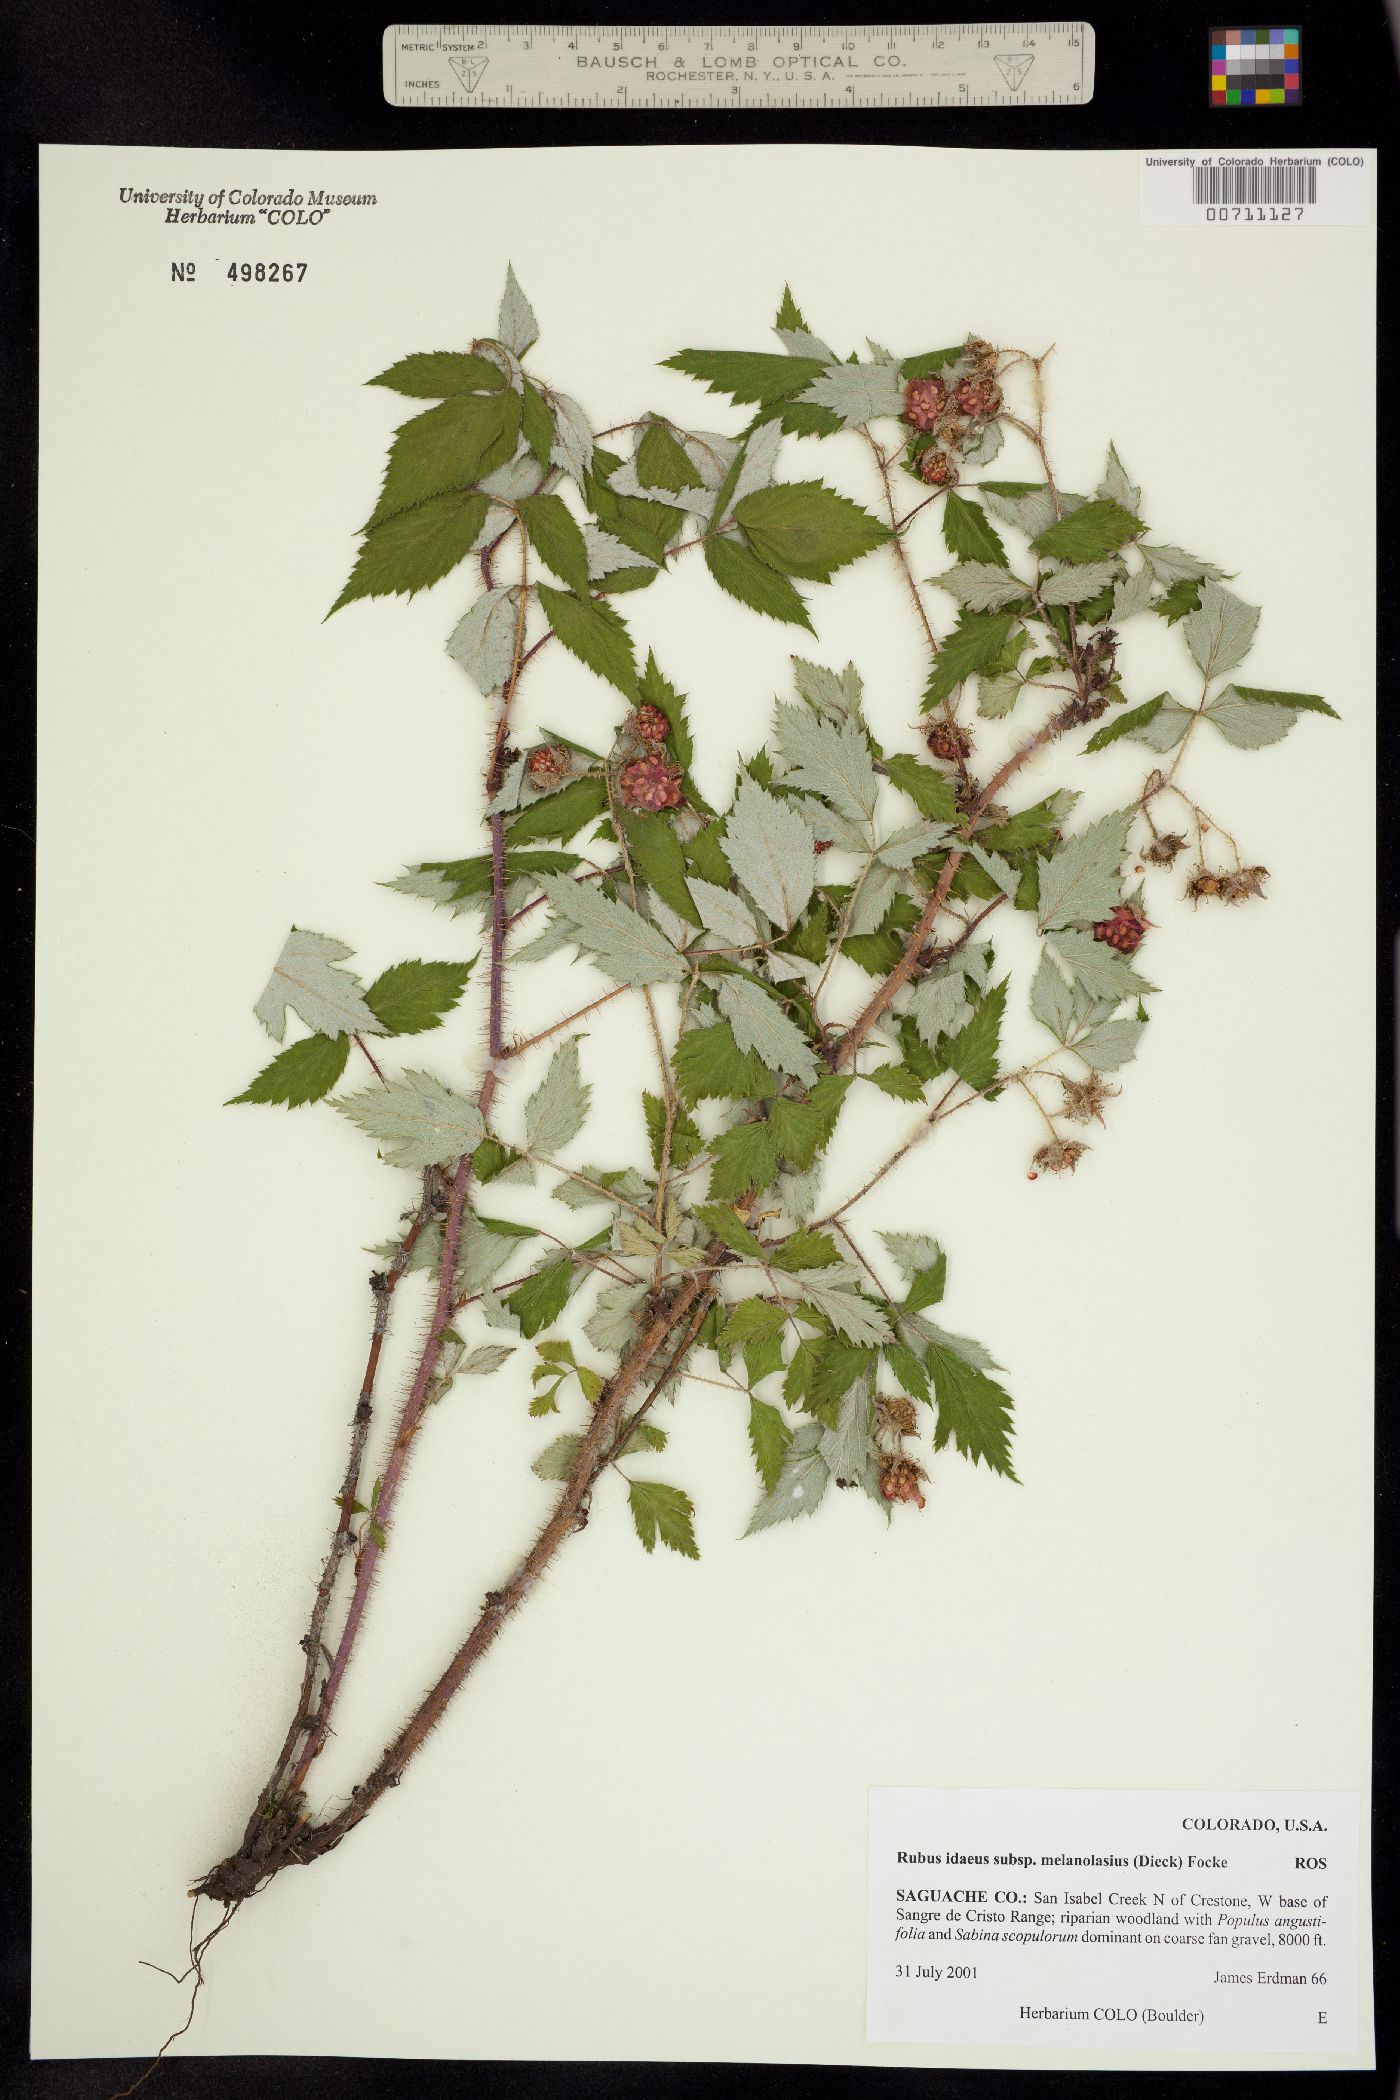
[384,21,1094,109]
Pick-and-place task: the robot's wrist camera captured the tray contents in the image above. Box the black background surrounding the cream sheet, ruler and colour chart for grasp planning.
[0,0,1400,2100]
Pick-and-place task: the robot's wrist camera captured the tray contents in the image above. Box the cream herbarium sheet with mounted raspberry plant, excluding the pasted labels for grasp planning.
[34,147,1375,2066]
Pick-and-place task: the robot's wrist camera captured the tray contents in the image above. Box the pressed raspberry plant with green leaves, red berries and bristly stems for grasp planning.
[188,275,1333,1945]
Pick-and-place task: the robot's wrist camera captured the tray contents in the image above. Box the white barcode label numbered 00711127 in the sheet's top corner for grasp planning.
[1138,147,1375,227]
